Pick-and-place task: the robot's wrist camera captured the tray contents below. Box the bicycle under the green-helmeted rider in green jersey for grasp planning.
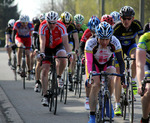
[74,55,83,98]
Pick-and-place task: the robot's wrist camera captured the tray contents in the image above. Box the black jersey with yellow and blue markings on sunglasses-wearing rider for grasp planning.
[113,20,143,48]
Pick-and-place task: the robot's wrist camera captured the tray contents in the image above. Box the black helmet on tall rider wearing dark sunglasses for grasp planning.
[120,6,135,17]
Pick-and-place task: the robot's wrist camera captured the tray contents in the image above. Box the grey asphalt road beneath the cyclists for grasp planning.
[0,51,142,123]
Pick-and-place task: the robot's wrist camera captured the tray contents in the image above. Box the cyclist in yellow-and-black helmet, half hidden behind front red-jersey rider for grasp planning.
[61,12,79,91]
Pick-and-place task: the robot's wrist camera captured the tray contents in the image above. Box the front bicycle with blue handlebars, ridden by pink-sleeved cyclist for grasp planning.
[89,71,124,123]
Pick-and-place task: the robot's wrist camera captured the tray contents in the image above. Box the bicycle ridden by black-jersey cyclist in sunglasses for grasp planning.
[120,57,135,123]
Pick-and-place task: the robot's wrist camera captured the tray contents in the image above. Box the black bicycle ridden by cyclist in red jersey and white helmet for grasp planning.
[46,56,67,115]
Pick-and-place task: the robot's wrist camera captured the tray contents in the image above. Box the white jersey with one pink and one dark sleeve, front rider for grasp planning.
[85,36,124,78]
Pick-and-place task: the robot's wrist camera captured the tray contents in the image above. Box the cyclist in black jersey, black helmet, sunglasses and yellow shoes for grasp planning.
[113,6,143,115]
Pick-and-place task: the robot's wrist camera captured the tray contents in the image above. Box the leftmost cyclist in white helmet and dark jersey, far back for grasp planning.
[5,19,15,66]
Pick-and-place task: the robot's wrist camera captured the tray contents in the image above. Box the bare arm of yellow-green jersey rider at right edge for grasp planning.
[136,49,146,87]
